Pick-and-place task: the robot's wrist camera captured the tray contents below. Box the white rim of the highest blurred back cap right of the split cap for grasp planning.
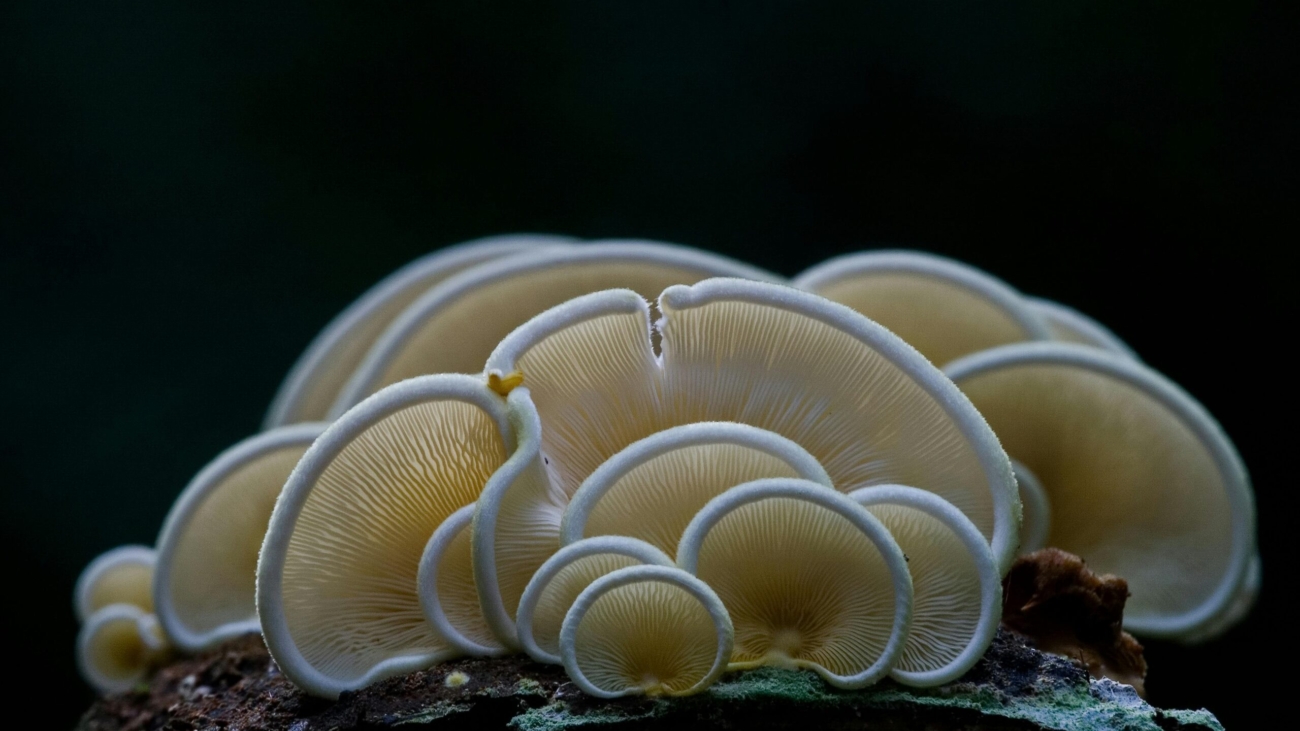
[793,250,1052,339]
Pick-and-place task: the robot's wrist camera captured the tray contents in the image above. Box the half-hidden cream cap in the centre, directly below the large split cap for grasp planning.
[560,421,833,553]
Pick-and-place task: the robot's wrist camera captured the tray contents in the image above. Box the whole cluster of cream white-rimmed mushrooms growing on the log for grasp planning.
[78,235,1260,697]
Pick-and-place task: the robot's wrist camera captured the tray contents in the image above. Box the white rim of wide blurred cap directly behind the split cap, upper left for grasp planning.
[330,241,780,416]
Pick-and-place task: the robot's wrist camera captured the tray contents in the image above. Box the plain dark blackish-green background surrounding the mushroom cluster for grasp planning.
[0,0,1297,728]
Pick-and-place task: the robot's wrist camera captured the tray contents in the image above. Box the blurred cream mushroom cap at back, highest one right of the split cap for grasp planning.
[794,251,1052,364]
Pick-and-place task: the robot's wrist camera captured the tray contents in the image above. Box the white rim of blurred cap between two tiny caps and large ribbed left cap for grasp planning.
[153,423,328,653]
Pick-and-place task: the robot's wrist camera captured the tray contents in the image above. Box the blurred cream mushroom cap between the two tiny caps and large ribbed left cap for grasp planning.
[153,423,326,652]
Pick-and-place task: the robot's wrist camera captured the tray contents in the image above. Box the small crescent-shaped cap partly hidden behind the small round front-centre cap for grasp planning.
[517,536,675,665]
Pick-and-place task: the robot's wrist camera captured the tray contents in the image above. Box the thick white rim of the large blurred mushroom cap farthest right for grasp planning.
[945,342,1255,639]
